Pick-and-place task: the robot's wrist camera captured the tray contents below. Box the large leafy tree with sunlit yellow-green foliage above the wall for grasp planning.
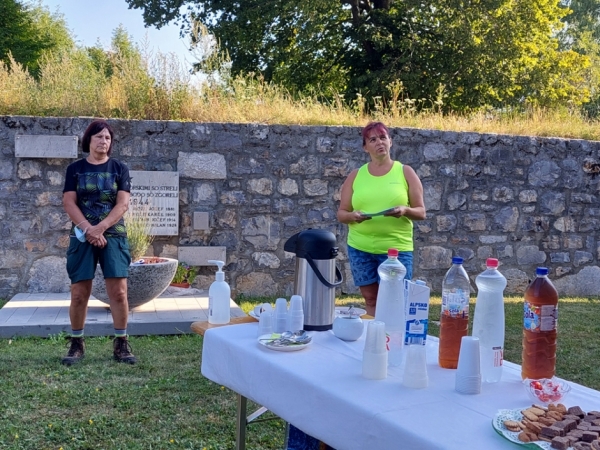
[127,0,589,110]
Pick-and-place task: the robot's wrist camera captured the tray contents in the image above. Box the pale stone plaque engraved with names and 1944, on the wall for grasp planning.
[129,170,179,236]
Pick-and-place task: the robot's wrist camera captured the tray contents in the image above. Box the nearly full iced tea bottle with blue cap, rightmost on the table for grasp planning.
[521,267,558,379]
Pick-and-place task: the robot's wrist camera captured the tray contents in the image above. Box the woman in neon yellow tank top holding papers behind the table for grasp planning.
[337,122,426,316]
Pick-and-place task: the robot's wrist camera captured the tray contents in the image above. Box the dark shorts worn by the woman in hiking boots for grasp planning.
[67,236,131,283]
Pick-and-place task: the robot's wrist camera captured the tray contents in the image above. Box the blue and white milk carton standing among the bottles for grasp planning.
[404,280,430,345]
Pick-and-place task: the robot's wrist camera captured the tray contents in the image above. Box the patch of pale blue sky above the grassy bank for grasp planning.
[37,0,194,68]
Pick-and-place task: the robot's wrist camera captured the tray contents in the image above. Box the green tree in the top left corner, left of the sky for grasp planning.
[0,0,75,76]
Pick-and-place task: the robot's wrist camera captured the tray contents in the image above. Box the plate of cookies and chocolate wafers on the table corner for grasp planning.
[492,403,600,450]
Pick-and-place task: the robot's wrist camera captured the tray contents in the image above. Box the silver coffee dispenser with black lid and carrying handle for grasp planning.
[283,228,343,331]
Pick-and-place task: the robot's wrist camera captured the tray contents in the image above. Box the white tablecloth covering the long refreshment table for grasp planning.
[202,323,600,450]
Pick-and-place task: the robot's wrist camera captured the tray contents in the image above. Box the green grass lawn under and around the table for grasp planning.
[0,297,600,450]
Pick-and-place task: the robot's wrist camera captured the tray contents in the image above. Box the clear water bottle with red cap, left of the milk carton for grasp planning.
[375,248,406,366]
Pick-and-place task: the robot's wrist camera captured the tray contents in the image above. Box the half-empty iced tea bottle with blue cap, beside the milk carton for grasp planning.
[438,256,471,369]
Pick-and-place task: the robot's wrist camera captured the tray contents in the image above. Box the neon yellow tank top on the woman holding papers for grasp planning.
[348,161,414,254]
